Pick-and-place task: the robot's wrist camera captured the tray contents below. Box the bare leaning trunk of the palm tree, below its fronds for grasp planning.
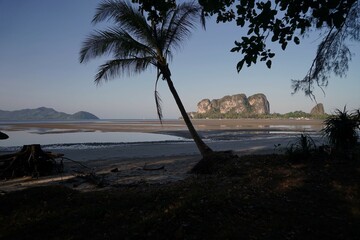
[163,68,213,157]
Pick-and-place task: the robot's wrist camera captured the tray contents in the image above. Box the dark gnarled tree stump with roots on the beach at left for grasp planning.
[0,144,64,179]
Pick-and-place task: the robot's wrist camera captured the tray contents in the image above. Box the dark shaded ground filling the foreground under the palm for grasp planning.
[0,151,360,239]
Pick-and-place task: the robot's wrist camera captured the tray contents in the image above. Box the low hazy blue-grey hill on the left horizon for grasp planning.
[0,107,99,121]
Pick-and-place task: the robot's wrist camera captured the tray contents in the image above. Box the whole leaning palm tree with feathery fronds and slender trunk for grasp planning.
[80,0,212,157]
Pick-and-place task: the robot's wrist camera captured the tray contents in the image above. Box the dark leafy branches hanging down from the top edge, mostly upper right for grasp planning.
[132,0,360,97]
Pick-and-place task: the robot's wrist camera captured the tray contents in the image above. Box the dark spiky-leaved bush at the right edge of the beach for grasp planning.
[322,106,360,152]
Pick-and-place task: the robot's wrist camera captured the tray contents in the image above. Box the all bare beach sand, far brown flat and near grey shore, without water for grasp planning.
[0,119,322,192]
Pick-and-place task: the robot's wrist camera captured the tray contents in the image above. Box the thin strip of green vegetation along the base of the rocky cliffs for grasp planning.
[192,111,328,119]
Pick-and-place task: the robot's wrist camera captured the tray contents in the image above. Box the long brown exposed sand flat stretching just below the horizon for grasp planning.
[0,119,323,133]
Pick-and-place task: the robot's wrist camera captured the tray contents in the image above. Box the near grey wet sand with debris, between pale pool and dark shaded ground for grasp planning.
[0,132,320,194]
